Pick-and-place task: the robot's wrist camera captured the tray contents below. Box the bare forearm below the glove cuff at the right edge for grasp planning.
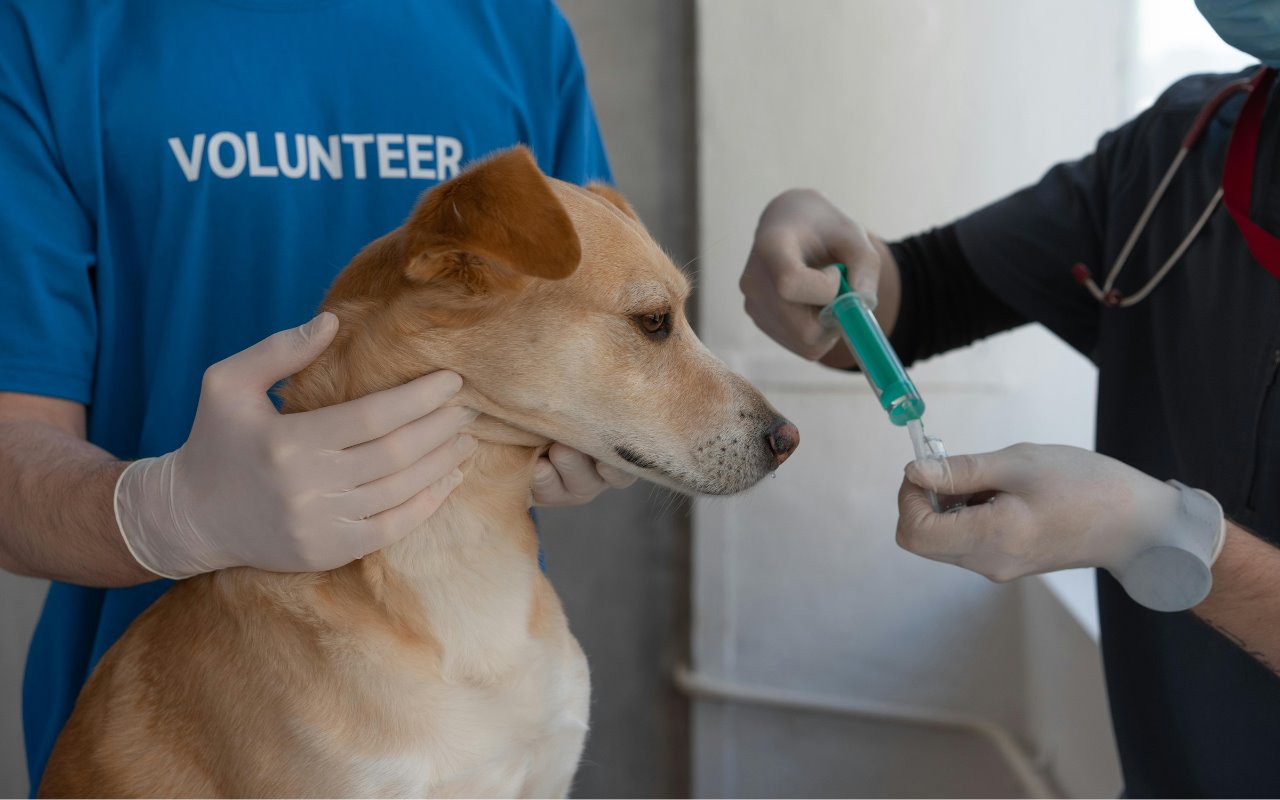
[1196,522,1280,675]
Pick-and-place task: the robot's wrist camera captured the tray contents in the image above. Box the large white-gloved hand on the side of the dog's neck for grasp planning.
[115,312,476,579]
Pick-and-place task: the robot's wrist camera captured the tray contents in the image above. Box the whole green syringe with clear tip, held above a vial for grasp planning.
[820,264,966,511]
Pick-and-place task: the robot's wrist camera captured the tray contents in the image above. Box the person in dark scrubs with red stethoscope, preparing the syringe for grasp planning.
[741,0,1280,796]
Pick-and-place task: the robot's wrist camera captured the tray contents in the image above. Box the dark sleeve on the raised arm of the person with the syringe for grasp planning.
[890,76,1234,362]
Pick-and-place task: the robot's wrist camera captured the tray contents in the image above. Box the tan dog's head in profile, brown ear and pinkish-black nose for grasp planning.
[285,147,799,494]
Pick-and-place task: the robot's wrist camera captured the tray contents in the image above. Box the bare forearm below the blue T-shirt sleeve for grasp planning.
[0,401,155,586]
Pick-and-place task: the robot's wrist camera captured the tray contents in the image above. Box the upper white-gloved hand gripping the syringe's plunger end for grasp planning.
[739,189,881,360]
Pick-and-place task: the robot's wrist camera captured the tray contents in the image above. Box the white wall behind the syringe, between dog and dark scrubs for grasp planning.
[694,0,1129,795]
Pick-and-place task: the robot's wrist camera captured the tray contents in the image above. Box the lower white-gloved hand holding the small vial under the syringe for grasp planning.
[897,444,1226,611]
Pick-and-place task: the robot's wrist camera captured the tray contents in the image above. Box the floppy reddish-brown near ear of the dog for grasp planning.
[402,146,582,282]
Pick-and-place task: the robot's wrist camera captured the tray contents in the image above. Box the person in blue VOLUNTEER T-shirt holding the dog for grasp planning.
[0,0,630,786]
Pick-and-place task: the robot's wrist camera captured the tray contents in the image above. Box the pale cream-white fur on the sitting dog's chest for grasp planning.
[312,499,590,797]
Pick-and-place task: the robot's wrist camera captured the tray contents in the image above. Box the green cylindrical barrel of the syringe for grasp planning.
[831,292,924,425]
